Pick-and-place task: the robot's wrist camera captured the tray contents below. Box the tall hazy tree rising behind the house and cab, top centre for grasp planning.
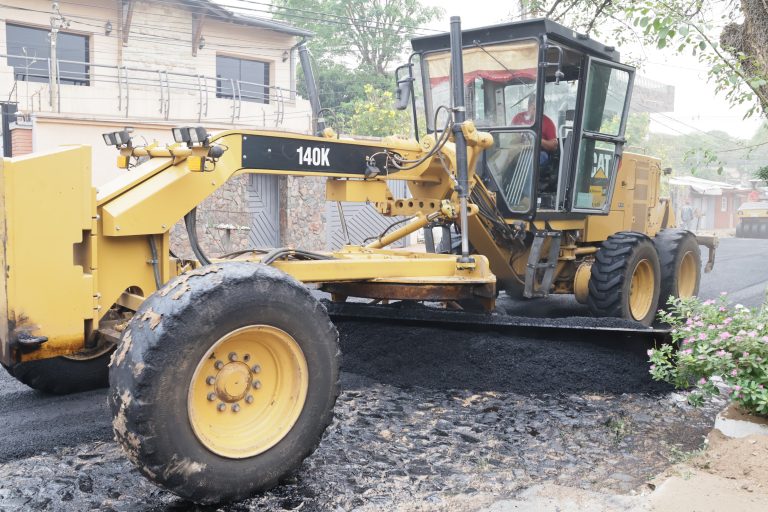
[274,0,442,75]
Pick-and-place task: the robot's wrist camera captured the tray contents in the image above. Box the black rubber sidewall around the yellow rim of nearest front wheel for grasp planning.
[113,264,338,503]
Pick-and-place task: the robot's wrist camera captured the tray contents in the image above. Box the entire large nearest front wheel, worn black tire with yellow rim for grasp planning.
[110,263,340,503]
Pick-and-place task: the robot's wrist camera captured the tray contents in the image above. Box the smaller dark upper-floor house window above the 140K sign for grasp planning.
[216,55,269,103]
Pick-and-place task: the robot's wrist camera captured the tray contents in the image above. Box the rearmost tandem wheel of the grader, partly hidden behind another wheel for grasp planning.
[653,229,701,308]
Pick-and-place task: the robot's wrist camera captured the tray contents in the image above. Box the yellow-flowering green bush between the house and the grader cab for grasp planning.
[347,84,411,137]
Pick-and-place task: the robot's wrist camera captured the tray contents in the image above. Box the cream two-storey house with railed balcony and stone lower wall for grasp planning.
[0,0,325,254]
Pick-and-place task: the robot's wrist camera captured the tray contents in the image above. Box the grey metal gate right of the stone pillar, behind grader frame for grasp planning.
[325,180,409,251]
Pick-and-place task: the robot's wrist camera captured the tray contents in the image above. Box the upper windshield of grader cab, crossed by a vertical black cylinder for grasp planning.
[424,40,539,131]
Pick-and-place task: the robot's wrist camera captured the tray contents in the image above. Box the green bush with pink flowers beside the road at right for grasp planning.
[648,294,768,416]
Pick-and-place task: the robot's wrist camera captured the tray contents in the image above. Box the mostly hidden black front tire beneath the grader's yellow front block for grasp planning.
[3,347,114,395]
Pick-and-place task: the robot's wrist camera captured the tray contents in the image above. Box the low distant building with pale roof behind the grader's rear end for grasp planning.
[669,176,750,231]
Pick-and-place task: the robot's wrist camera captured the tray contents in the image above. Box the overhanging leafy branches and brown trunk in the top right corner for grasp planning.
[523,0,768,116]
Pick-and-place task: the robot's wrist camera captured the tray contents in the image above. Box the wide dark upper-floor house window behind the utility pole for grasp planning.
[5,23,91,85]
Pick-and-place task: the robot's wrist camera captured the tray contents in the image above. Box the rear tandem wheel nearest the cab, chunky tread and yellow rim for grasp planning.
[587,231,660,325]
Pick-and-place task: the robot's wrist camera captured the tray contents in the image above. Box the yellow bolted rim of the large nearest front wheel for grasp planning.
[187,325,309,459]
